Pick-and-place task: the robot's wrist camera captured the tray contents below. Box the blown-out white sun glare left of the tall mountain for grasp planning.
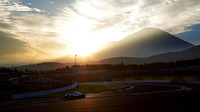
[56,9,125,56]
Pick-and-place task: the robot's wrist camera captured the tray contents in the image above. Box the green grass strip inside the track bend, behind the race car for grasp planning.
[45,84,128,96]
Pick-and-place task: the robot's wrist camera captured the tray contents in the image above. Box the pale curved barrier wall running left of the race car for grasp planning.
[12,82,79,99]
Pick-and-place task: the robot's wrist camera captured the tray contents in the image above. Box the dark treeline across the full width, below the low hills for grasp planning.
[0,59,200,73]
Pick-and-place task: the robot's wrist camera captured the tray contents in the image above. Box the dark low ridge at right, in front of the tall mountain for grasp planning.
[98,45,200,64]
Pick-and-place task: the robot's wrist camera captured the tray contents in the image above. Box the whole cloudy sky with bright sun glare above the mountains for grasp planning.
[0,0,200,64]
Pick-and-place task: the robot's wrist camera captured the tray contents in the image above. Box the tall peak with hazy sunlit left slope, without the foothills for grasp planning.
[92,28,194,59]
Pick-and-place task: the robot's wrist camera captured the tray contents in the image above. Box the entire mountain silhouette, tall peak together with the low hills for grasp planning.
[12,28,197,70]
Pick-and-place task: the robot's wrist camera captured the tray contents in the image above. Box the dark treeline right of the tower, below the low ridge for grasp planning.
[82,59,200,71]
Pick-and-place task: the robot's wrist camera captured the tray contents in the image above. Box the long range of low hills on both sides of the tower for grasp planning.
[14,45,200,71]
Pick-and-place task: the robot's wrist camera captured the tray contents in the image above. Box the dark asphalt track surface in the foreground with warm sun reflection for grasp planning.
[0,84,200,112]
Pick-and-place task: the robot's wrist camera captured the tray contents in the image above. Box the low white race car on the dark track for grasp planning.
[64,92,86,100]
